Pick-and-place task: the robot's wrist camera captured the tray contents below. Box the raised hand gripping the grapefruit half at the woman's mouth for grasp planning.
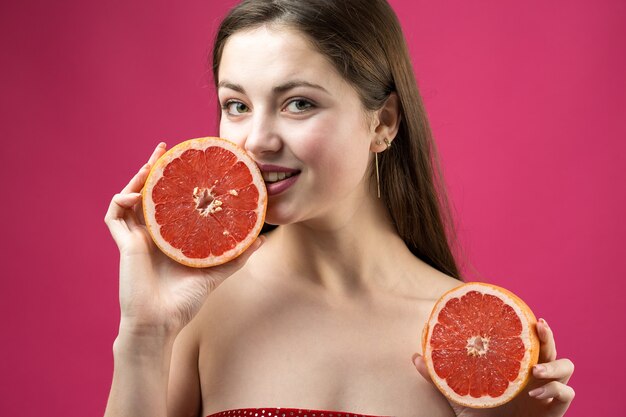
[104,143,263,336]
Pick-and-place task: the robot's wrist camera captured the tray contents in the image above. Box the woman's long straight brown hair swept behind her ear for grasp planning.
[212,0,460,279]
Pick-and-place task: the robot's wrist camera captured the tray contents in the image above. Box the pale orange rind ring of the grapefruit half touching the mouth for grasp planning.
[142,137,267,268]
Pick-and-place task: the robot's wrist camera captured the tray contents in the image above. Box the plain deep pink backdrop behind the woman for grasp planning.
[0,0,626,417]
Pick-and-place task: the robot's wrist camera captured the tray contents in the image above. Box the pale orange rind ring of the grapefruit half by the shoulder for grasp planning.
[422,282,539,408]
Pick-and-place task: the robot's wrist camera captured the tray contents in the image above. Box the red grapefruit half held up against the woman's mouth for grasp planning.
[142,137,267,268]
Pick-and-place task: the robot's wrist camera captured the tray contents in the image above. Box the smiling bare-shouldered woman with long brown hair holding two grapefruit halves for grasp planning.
[106,0,573,417]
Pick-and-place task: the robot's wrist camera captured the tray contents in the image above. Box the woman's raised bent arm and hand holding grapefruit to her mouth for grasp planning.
[105,144,263,417]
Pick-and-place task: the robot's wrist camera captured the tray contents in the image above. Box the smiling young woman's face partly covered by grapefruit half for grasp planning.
[218,27,374,224]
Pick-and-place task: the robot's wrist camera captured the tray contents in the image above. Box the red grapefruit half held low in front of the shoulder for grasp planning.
[422,282,539,408]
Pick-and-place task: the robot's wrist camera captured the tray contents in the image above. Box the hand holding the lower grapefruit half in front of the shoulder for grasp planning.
[413,319,574,417]
